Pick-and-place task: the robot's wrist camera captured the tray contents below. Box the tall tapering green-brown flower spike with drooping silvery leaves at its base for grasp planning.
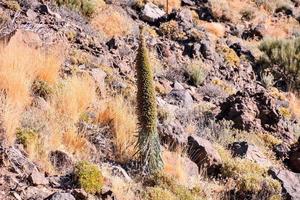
[136,27,163,174]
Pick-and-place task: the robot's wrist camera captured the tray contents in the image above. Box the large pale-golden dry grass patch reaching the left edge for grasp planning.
[0,36,61,144]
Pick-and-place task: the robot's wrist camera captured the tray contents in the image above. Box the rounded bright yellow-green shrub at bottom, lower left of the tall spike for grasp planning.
[74,161,104,194]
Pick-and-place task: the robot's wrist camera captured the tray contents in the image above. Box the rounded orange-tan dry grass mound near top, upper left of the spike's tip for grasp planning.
[91,5,133,38]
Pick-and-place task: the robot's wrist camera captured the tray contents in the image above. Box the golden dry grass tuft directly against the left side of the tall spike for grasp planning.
[97,96,137,162]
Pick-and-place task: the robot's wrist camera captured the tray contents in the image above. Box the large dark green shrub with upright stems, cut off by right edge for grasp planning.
[259,38,300,91]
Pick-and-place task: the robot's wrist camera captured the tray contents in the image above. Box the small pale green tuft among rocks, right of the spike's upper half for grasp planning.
[186,60,208,86]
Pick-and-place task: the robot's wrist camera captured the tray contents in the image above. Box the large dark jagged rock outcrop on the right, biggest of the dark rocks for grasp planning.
[217,90,294,141]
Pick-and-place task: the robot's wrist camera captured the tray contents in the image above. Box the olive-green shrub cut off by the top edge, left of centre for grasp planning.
[56,0,99,17]
